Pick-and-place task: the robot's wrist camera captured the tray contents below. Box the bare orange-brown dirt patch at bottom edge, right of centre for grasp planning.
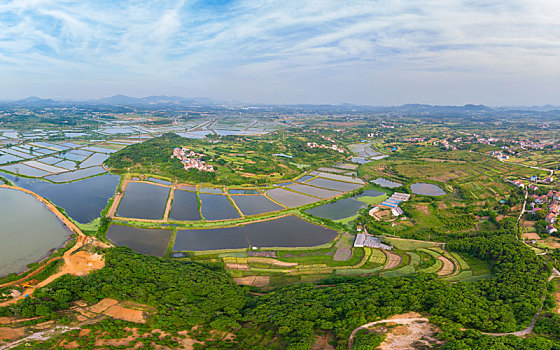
[379,321,439,350]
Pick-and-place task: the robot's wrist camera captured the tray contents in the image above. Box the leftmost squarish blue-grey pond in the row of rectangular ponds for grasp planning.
[117,182,169,220]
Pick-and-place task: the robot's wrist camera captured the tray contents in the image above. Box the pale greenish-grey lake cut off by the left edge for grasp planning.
[0,188,71,276]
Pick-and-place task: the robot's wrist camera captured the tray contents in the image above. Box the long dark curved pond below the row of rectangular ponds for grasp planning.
[173,216,338,251]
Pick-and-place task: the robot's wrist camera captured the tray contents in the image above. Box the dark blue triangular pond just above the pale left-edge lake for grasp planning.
[0,173,119,224]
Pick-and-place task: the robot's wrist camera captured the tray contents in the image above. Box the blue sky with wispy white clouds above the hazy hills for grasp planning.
[0,0,560,106]
